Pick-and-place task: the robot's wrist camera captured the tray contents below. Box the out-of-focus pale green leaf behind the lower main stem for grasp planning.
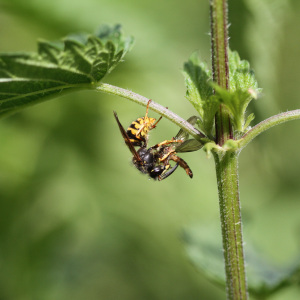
[183,224,300,297]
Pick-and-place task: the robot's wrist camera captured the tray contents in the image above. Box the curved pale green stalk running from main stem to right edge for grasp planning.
[237,109,300,149]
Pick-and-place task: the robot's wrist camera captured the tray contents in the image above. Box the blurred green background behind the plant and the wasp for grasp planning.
[0,0,300,300]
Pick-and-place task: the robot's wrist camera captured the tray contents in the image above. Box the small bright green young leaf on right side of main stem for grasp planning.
[213,50,260,132]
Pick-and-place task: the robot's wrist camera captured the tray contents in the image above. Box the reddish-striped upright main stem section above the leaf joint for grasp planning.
[210,0,233,146]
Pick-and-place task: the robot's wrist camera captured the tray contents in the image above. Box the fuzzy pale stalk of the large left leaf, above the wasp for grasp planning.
[96,83,205,141]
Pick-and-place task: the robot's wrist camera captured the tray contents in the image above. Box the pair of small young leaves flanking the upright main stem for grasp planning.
[184,51,260,136]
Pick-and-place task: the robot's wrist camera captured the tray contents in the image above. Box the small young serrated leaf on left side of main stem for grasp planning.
[183,53,219,136]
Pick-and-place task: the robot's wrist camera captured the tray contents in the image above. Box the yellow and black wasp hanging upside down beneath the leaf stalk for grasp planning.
[114,100,202,181]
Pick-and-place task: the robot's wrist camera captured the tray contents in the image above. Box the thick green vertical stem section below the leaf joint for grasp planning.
[214,151,248,300]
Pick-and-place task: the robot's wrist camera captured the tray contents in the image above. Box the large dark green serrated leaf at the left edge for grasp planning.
[0,25,133,115]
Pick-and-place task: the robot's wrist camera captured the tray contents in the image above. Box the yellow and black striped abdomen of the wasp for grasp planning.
[127,117,156,147]
